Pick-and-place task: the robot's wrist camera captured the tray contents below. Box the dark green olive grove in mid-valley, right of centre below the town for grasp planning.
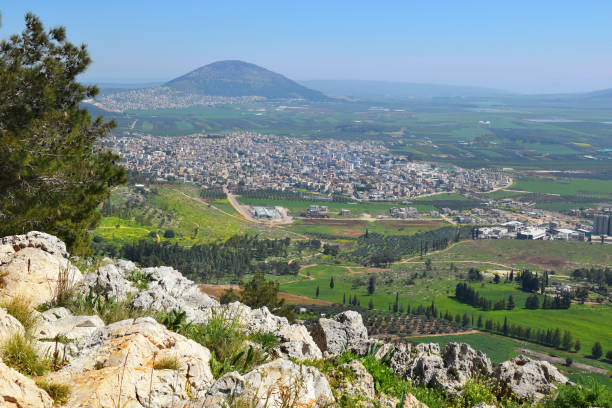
[350,226,473,266]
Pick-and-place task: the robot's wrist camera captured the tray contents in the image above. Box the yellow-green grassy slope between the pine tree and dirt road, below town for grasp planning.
[93,184,291,246]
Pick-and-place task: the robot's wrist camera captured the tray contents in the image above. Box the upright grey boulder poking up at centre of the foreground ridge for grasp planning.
[310,310,370,357]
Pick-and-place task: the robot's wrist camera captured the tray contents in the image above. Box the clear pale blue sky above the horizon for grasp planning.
[0,0,612,93]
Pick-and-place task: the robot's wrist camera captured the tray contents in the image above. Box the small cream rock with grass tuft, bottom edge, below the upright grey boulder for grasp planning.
[331,360,376,401]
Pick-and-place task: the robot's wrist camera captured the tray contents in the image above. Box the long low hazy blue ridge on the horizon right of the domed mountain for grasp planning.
[301,80,512,100]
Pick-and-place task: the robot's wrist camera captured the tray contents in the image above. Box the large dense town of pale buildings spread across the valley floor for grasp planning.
[105,132,512,200]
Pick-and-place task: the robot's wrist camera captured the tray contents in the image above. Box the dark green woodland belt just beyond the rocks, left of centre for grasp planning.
[100,235,299,282]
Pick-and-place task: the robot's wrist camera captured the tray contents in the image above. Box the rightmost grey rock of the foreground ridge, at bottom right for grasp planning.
[494,355,569,400]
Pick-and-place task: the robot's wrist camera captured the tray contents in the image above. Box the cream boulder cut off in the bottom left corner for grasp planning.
[0,359,53,408]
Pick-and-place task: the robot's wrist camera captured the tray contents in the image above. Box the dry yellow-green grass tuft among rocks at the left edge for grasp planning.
[0,334,50,376]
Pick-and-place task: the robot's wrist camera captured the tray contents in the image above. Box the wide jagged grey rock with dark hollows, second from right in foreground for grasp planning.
[391,343,492,395]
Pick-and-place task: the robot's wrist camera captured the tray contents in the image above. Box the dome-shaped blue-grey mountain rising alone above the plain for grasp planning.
[166,61,328,100]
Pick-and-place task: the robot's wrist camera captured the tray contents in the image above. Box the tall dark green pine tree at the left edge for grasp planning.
[0,13,126,254]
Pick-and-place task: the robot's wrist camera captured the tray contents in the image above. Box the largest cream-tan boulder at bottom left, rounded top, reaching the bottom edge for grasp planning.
[53,317,213,408]
